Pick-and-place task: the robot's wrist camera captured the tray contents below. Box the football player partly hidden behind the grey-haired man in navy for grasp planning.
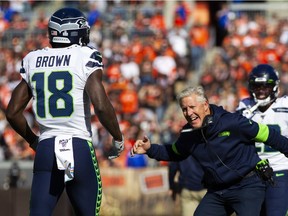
[237,64,288,216]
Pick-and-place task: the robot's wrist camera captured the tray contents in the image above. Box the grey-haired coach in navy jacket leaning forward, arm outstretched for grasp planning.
[131,86,288,216]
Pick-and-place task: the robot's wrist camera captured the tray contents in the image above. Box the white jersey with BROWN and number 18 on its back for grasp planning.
[20,45,103,140]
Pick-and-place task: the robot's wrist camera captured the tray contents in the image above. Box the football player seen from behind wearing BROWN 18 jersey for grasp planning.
[6,8,124,216]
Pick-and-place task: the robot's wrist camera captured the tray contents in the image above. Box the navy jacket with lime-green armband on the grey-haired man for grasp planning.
[147,104,288,190]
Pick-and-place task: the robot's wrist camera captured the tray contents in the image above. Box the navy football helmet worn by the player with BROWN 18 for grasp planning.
[48,8,90,47]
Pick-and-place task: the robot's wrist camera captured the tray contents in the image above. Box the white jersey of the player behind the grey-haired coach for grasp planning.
[237,96,288,171]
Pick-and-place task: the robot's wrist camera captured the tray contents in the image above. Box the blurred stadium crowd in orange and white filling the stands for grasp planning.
[0,0,288,168]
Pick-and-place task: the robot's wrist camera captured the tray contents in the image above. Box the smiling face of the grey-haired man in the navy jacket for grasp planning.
[180,94,210,128]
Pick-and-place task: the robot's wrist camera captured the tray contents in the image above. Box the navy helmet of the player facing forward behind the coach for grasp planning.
[248,64,280,106]
